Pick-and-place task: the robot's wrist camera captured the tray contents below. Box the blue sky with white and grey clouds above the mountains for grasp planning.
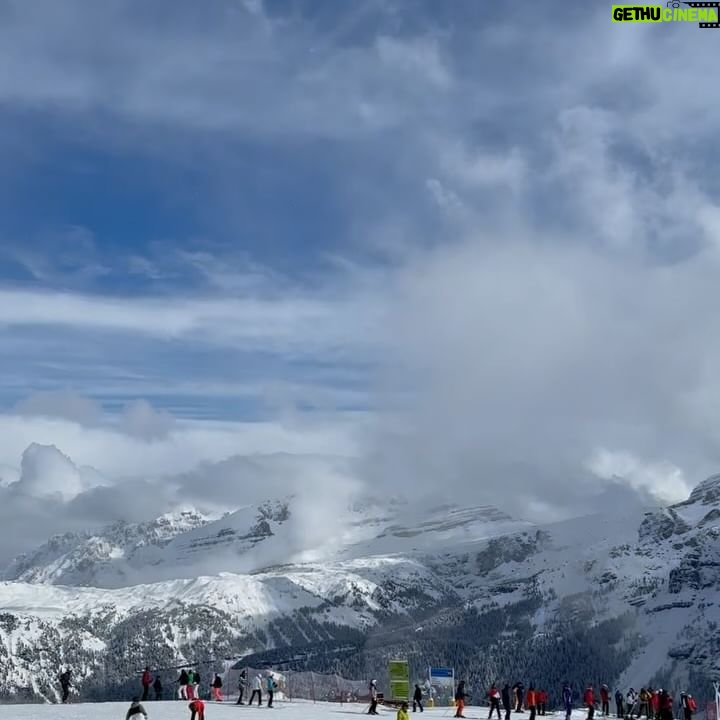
[0,0,720,552]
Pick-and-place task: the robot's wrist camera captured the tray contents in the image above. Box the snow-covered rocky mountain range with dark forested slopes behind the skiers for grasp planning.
[0,476,720,697]
